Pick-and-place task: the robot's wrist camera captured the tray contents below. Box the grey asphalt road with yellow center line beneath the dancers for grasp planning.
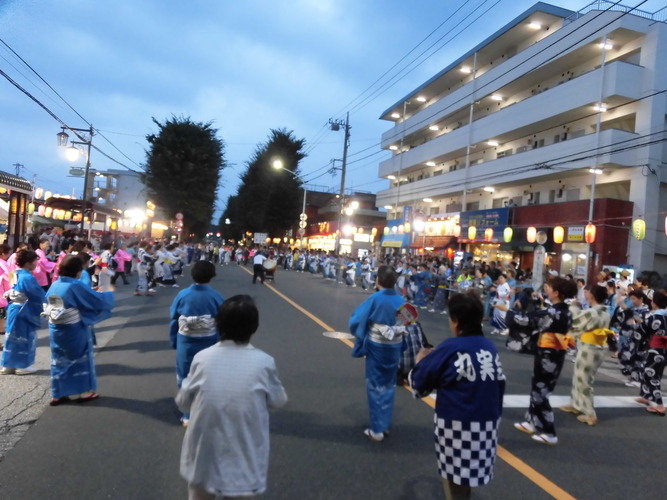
[0,265,667,500]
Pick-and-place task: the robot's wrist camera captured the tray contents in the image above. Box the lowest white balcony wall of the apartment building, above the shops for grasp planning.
[377,129,638,207]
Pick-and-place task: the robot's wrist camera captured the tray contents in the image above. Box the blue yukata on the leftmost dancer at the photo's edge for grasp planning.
[1,269,44,369]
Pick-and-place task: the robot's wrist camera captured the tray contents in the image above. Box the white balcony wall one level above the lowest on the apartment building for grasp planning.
[379,61,644,177]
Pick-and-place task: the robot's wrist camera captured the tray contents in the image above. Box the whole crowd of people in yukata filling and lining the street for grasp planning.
[0,232,667,498]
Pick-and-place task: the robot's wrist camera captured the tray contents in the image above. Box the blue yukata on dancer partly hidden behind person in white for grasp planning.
[169,284,225,387]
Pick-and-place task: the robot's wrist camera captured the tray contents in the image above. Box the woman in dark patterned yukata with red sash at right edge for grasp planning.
[636,291,667,417]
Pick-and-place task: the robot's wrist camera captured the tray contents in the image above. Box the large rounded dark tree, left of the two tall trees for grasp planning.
[142,117,227,237]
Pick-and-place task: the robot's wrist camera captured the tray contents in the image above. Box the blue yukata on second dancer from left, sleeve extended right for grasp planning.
[46,276,115,398]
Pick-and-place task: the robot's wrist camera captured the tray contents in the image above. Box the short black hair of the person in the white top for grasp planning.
[215,295,259,345]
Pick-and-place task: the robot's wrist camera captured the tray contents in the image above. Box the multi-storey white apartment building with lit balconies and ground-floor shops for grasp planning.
[377,1,667,279]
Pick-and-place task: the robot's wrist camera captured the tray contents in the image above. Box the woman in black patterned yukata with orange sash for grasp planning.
[514,276,577,446]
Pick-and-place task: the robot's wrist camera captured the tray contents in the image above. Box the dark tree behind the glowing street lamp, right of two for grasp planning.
[220,129,306,238]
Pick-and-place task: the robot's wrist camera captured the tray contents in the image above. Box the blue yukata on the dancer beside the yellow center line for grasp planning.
[349,288,405,433]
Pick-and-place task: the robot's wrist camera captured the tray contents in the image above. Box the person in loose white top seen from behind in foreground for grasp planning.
[176,295,287,500]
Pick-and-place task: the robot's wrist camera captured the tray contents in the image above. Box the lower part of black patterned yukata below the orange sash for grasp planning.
[526,347,567,436]
